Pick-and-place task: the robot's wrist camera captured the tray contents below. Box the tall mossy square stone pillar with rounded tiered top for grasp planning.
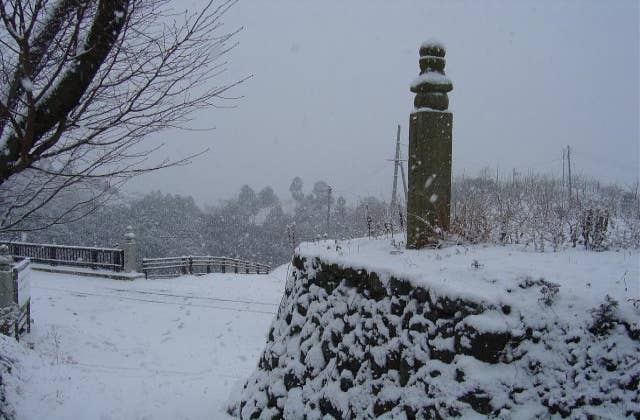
[407,42,453,249]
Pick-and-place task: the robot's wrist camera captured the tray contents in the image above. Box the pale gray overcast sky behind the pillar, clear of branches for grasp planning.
[129,0,640,204]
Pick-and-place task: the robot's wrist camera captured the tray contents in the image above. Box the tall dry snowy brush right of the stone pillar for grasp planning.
[451,175,640,252]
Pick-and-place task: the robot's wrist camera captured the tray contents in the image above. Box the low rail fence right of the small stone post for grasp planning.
[142,256,271,278]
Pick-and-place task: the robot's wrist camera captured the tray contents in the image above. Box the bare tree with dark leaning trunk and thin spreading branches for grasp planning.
[0,0,245,233]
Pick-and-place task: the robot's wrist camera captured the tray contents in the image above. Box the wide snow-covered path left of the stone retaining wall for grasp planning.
[15,267,286,419]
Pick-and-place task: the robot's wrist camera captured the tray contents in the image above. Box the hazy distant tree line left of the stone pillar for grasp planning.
[12,177,387,265]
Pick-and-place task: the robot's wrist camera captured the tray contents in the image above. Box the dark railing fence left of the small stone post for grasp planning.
[2,242,124,271]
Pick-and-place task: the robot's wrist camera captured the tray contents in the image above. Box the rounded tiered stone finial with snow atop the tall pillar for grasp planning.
[411,41,453,111]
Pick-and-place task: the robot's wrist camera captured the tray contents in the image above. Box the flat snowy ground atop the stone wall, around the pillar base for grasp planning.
[297,238,640,322]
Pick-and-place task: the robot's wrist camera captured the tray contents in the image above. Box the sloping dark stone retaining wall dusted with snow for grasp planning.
[229,241,640,419]
